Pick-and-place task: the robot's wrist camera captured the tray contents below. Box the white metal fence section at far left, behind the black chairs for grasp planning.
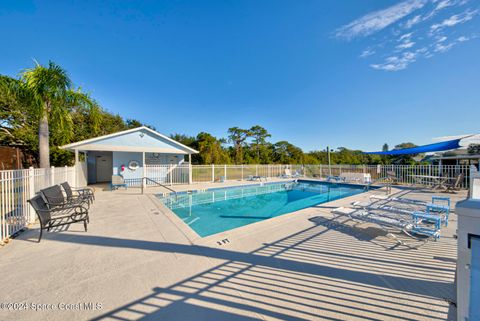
[0,167,76,244]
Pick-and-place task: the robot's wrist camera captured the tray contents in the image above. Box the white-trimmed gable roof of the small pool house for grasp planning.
[60,126,198,154]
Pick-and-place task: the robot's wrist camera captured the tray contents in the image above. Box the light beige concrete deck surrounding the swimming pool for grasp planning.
[0,182,466,321]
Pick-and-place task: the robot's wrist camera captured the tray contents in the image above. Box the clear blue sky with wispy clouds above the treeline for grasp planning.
[0,0,480,151]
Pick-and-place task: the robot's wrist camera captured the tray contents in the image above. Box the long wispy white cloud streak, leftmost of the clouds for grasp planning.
[335,0,428,39]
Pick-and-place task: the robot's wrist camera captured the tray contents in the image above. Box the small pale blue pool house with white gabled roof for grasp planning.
[61,126,198,186]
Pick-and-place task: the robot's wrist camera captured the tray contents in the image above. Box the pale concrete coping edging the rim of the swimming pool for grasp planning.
[148,180,379,245]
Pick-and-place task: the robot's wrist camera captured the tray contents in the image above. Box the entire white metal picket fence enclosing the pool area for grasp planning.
[0,163,475,243]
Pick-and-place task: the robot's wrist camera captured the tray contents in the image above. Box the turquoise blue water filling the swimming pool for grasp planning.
[159,181,363,237]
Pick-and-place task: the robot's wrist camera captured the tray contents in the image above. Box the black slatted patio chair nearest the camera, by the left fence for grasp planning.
[28,195,89,243]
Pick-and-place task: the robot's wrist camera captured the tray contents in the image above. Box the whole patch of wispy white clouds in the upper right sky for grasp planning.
[335,0,480,71]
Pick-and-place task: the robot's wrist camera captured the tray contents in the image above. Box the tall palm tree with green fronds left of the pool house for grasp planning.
[21,61,98,168]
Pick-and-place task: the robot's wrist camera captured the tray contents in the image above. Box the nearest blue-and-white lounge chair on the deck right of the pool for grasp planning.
[332,207,440,241]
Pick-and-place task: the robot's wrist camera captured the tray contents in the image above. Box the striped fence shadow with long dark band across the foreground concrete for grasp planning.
[38,217,454,321]
